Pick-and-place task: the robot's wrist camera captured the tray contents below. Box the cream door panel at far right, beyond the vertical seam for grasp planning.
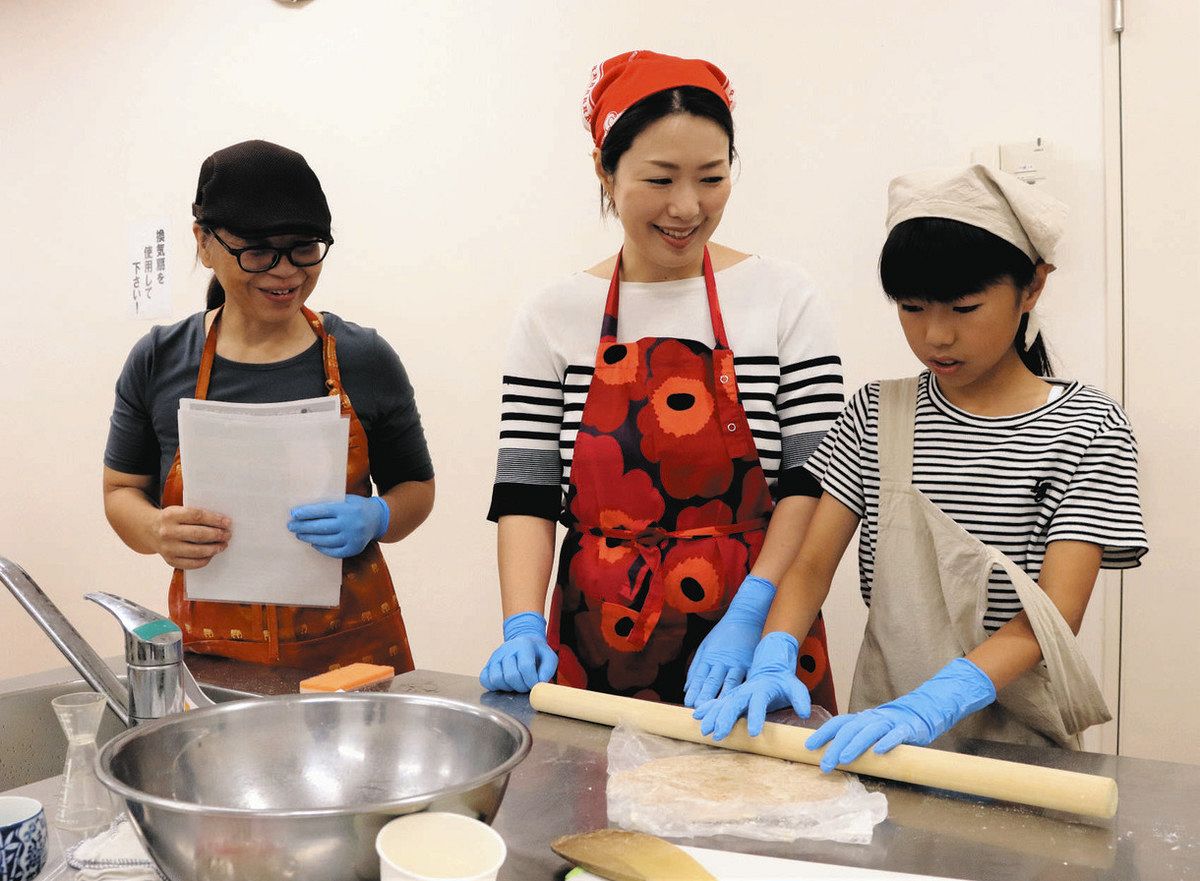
[1118,0,1200,762]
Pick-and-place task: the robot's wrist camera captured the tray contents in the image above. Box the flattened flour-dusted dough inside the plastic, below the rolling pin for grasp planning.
[608,751,847,823]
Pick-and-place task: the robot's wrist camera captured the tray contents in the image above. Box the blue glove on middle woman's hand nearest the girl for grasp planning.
[683,575,775,707]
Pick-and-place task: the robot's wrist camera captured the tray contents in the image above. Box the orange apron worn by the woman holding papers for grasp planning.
[162,308,413,673]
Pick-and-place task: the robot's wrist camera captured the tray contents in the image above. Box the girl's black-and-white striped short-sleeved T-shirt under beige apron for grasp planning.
[808,372,1148,631]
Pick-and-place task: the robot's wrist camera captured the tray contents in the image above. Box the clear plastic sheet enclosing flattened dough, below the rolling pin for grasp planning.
[607,714,888,844]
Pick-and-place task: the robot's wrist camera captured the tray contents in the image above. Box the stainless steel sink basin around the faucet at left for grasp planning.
[0,676,248,792]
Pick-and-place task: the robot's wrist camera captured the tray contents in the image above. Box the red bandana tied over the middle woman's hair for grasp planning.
[583,49,733,146]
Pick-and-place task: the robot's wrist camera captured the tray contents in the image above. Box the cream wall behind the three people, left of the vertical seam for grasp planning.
[0,0,1106,739]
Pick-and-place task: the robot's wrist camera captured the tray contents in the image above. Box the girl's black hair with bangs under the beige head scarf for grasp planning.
[878,219,1054,376]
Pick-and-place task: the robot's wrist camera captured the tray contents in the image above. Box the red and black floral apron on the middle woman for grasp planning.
[547,250,836,713]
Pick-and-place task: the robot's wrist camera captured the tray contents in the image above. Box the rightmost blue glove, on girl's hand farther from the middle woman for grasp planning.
[804,658,996,773]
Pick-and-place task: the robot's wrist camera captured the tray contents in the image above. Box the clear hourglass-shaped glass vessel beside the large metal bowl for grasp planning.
[50,691,116,835]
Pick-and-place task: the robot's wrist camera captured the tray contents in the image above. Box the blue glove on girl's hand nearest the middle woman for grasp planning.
[692,630,812,741]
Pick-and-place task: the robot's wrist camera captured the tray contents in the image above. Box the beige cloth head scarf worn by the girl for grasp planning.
[888,166,1067,348]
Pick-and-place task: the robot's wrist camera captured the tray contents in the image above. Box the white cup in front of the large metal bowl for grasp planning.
[376,811,508,881]
